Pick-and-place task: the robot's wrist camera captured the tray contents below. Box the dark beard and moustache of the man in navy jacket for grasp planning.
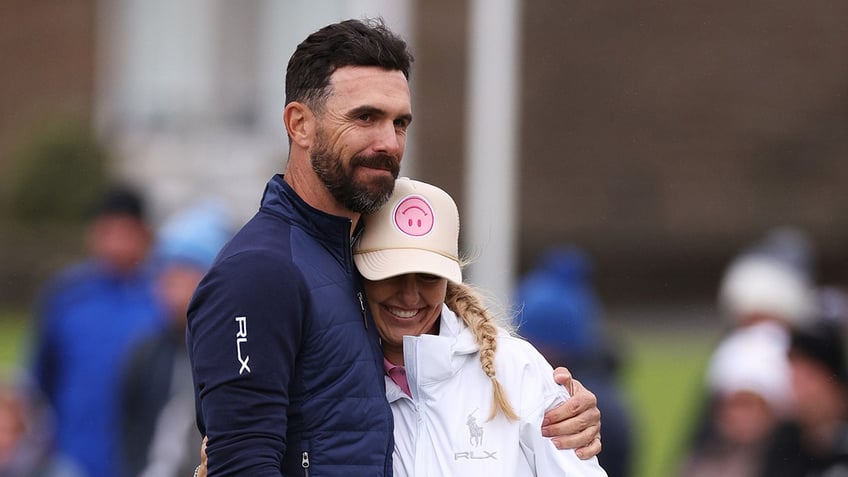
[311,140,400,214]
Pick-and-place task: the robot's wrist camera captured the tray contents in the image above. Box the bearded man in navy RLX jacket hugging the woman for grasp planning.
[187,16,600,477]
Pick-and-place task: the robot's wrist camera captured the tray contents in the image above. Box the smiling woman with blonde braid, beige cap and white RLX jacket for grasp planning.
[354,178,606,477]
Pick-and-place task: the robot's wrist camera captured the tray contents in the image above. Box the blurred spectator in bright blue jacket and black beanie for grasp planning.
[33,187,164,477]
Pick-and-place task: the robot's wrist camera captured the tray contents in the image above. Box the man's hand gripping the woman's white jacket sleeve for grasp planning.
[542,367,601,459]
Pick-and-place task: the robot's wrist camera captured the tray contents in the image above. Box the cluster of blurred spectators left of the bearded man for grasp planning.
[0,186,234,477]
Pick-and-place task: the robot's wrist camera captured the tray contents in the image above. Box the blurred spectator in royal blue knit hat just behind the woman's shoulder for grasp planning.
[515,245,635,477]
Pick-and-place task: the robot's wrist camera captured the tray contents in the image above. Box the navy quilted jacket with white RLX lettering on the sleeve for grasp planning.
[187,175,393,477]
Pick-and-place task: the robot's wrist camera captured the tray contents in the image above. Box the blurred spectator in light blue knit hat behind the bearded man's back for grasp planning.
[121,198,233,477]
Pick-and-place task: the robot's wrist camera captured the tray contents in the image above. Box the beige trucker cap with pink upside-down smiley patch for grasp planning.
[353,177,462,283]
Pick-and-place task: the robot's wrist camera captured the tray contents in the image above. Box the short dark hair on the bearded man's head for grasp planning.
[286,19,413,108]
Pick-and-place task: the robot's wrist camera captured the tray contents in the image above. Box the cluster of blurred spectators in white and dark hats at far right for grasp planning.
[680,227,848,477]
